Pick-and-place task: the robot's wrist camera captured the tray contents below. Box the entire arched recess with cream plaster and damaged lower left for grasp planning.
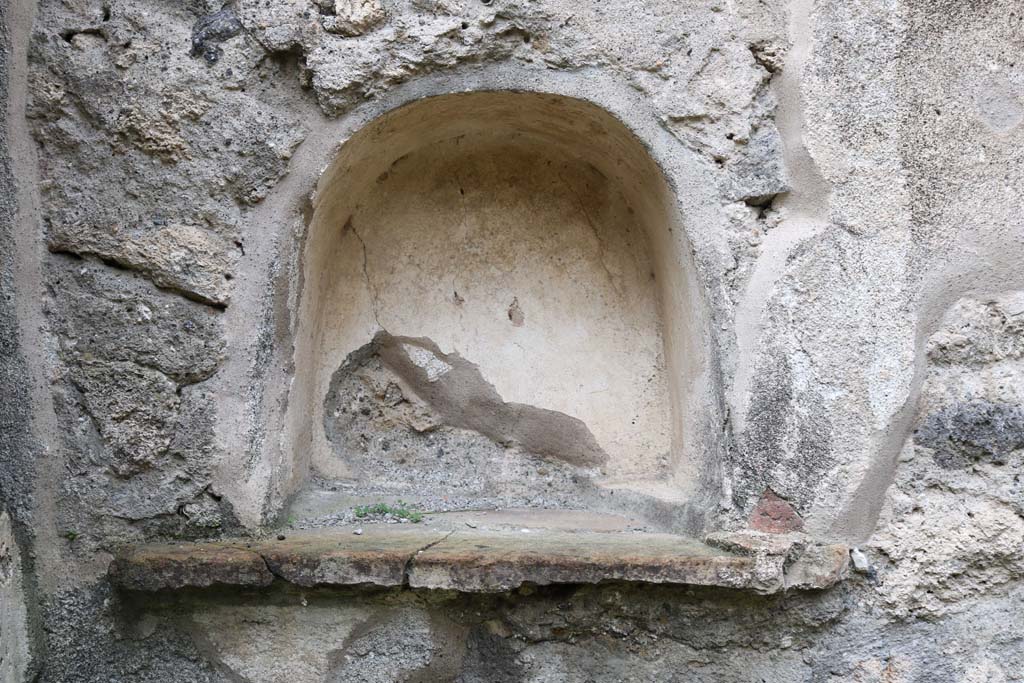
[286,91,713,528]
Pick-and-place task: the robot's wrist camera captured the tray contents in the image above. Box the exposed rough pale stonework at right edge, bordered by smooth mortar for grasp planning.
[872,291,1024,618]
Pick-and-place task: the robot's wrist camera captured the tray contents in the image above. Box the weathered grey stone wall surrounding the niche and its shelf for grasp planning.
[6,0,1024,682]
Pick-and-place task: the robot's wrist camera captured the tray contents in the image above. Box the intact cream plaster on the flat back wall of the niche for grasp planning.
[307,108,671,485]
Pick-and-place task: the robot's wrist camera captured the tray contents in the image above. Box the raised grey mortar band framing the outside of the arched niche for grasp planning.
[216,74,728,532]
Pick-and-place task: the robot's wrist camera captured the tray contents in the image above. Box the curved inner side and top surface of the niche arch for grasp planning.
[284,90,716,520]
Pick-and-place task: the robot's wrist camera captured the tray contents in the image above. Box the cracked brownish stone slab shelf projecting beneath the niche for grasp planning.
[110,524,849,594]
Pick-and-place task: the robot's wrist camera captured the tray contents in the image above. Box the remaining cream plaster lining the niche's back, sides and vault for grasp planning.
[286,93,699,493]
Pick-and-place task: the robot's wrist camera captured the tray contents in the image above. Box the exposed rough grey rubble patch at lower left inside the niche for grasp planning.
[312,334,589,510]
